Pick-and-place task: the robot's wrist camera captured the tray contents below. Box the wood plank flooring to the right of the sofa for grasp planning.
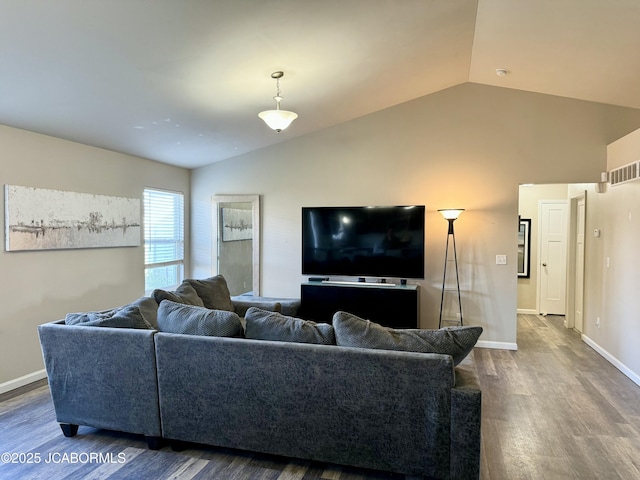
[474,315,640,480]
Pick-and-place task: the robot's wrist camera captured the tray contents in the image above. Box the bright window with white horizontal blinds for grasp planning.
[144,188,184,295]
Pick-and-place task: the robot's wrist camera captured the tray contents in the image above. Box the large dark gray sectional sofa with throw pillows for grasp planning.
[39,276,481,479]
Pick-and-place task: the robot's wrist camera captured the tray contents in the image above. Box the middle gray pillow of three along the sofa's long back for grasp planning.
[244,307,336,345]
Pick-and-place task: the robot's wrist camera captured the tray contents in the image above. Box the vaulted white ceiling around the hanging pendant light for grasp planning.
[0,0,640,168]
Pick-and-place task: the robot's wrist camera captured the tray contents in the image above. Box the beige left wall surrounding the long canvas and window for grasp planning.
[0,126,190,393]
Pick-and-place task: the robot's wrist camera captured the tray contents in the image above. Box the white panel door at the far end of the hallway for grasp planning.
[538,200,568,315]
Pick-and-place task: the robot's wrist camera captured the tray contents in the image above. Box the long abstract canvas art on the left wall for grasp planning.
[5,185,141,251]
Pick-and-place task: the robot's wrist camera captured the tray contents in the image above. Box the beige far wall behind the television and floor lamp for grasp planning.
[192,84,640,348]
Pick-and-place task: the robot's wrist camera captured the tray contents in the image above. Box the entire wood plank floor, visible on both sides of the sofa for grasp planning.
[0,315,640,480]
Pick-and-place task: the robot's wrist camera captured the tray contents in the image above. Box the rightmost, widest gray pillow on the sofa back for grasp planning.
[333,312,482,365]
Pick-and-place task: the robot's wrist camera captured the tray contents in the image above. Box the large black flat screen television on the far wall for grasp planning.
[302,205,425,279]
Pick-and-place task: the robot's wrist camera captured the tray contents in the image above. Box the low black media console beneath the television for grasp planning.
[300,281,420,328]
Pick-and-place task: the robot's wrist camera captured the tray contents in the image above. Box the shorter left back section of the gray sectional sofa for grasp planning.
[38,320,161,437]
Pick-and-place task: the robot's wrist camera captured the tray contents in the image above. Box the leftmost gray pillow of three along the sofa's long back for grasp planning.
[158,300,242,337]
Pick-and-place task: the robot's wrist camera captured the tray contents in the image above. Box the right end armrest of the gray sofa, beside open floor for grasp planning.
[450,354,482,479]
